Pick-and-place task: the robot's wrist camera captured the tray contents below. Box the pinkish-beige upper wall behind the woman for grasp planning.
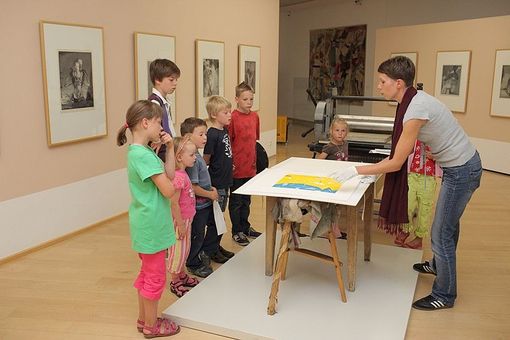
[372,16,510,142]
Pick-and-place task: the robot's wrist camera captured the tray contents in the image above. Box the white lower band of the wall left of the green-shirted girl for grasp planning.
[0,168,131,259]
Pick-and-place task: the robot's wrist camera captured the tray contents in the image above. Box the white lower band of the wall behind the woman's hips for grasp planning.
[470,137,510,175]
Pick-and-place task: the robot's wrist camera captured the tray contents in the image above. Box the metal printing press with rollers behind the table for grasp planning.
[302,96,394,163]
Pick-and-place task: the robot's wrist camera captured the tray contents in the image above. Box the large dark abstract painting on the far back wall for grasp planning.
[308,25,367,99]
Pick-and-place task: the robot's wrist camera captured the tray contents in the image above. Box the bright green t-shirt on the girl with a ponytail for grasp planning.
[127,145,175,254]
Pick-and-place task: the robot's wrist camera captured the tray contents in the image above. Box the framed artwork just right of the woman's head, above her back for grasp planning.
[434,51,471,112]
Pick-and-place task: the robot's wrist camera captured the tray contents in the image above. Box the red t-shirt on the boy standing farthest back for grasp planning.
[228,110,260,178]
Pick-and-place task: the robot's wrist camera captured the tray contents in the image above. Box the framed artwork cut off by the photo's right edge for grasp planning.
[491,50,510,117]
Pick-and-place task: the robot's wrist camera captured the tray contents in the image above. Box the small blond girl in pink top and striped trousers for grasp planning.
[168,135,198,297]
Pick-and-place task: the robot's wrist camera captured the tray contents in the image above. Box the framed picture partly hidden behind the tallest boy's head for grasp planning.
[134,32,177,108]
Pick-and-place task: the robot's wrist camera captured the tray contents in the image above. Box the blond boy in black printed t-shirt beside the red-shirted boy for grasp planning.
[204,96,234,263]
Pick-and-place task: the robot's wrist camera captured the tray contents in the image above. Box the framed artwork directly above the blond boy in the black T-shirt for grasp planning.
[195,39,225,119]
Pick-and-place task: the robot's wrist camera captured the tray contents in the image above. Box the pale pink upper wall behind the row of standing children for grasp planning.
[0,0,279,202]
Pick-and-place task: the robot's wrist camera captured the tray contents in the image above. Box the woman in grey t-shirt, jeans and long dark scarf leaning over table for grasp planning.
[332,56,482,310]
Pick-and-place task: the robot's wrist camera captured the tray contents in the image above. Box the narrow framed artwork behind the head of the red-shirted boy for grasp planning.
[238,45,260,111]
